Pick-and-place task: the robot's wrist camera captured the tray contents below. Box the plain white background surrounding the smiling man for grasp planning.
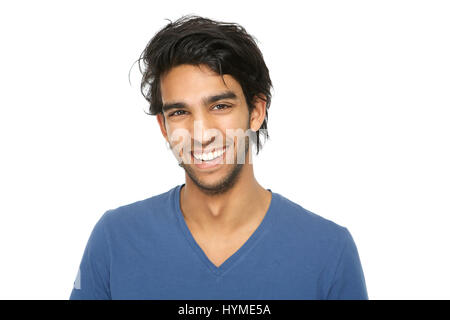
[0,0,450,299]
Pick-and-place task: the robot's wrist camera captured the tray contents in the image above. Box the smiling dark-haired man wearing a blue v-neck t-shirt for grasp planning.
[70,16,368,299]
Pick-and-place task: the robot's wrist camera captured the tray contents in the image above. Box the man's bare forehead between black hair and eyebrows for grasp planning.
[160,64,244,103]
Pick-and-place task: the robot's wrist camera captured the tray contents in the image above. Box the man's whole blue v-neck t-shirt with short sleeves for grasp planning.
[70,185,368,300]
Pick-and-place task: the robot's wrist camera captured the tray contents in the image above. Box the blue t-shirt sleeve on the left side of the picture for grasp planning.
[70,211,111,300]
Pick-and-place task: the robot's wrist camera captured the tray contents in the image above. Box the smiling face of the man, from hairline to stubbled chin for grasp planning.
[158,65,251,194]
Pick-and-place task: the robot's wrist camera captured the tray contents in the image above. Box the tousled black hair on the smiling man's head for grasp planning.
[137,15,273,154]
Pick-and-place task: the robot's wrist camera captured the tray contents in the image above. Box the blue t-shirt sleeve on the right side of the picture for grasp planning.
[327,227,369,300]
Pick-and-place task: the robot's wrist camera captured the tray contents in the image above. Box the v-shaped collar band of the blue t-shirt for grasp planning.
[172,183,278,276]
